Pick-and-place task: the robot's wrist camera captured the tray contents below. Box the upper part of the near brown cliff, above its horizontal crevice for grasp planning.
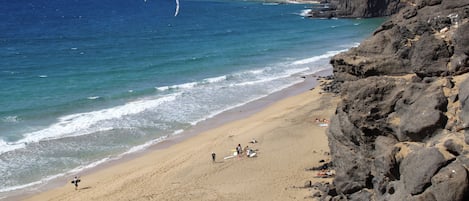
[331,1,469,81]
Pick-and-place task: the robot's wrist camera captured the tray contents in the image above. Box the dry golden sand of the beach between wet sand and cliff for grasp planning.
[21,76,337,201]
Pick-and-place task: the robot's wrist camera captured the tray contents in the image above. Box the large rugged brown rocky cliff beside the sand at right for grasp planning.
[320,0,469,201]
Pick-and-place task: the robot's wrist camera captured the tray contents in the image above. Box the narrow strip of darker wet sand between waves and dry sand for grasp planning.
[7,69,332,200]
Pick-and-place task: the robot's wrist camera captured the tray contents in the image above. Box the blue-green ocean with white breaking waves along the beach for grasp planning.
[0,0,383,198]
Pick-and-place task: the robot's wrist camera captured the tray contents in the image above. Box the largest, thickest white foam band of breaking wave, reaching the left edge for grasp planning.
[0,93,179,154]
